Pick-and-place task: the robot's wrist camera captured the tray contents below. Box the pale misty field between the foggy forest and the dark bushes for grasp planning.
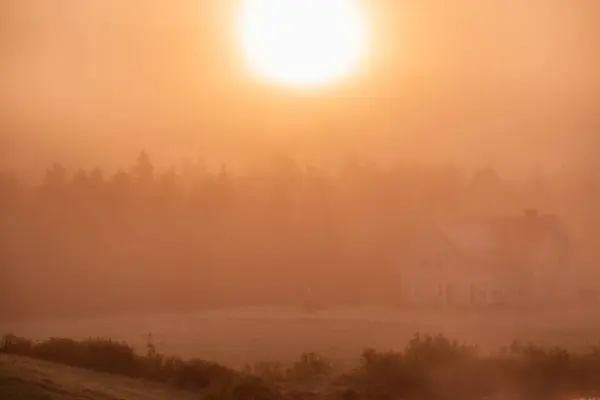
[0,308,600,367]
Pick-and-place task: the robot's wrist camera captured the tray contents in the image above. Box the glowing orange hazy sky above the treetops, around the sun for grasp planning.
[0,0,600,172]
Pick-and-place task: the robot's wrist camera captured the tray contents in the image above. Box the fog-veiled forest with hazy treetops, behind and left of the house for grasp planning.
[0,152,600,318]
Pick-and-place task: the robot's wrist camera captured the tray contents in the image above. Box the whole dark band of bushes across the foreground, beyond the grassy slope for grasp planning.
[2,335,600,399]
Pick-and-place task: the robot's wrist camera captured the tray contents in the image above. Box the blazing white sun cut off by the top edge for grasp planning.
[239,0,367,86]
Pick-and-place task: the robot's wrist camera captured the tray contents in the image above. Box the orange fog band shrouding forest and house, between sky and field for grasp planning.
[0,153,600,319]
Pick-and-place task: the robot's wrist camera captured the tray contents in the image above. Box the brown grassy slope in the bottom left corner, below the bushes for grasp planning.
[0,354,198,400]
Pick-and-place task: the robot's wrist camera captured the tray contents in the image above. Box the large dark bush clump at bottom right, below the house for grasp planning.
[342,335,600,399]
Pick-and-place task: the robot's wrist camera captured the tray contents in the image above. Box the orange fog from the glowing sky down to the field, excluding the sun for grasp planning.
[0,0,600,354]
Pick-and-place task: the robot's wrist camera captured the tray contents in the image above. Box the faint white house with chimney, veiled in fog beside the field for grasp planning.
[401,211,573,306]
